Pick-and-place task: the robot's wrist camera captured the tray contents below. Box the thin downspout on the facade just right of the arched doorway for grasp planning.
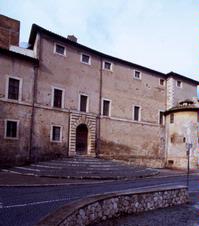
[96,57,103,157]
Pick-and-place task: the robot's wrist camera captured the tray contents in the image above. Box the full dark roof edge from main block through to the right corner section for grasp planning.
[29,24,199,85]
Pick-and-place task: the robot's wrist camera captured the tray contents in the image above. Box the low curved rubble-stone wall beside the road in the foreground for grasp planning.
[37,186,189,226]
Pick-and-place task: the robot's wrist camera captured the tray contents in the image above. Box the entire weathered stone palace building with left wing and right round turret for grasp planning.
[0,15,199,168]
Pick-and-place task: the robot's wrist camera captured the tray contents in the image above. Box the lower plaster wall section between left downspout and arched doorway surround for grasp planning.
[32,107,69,161]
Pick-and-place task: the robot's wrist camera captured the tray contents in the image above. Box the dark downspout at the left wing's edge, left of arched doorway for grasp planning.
[29,35,42,162]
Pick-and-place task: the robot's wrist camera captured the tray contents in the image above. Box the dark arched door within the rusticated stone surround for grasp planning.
[76,124,88,155]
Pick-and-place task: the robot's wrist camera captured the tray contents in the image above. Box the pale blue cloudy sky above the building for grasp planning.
[0,0,199,80]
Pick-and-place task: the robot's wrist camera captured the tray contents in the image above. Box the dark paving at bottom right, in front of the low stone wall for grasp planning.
[92,193,199,226]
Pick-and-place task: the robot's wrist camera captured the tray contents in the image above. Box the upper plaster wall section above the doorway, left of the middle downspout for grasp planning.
[37,38,100,114]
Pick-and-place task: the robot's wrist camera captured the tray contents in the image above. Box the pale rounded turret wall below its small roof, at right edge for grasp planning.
[166,111,199,168]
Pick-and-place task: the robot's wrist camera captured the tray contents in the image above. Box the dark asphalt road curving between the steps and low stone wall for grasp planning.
[0,175,199,226]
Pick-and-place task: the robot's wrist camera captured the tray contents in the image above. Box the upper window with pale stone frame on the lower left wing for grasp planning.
[7,77,22,100]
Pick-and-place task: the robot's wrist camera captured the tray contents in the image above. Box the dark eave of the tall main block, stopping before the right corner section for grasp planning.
[29,24,167,78]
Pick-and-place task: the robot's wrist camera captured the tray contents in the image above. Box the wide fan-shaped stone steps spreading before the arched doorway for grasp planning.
[3,156,158,180]
